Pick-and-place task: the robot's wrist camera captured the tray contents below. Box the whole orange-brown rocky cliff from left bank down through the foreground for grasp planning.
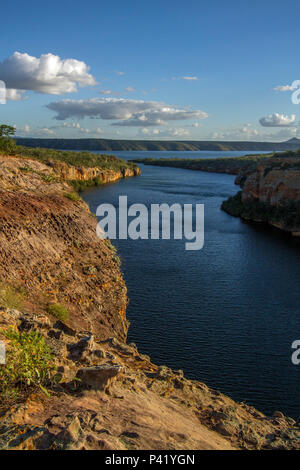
[0,153,300,450]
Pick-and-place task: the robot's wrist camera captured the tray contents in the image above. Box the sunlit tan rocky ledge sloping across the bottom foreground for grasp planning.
[0,309,300,450]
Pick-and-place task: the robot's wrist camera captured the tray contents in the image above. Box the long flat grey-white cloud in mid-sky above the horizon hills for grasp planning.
[47,98,208,127]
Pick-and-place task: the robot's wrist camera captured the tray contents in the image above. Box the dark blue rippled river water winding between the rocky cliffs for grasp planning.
[83,152,300,417]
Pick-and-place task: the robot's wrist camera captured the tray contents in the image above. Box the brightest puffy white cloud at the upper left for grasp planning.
[0,52,97,100]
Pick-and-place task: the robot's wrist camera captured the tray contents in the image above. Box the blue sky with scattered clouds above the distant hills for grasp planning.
[0,0,300,141]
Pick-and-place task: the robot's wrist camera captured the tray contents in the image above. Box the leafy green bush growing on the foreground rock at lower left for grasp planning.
[0,328,55,406]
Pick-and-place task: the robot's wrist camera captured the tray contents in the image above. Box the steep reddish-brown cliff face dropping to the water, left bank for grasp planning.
[0,157,127,340]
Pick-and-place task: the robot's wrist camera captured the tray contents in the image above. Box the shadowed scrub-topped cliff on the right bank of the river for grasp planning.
[222,157,300,236]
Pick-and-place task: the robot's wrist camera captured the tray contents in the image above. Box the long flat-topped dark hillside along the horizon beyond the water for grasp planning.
[16,137,300,152]
